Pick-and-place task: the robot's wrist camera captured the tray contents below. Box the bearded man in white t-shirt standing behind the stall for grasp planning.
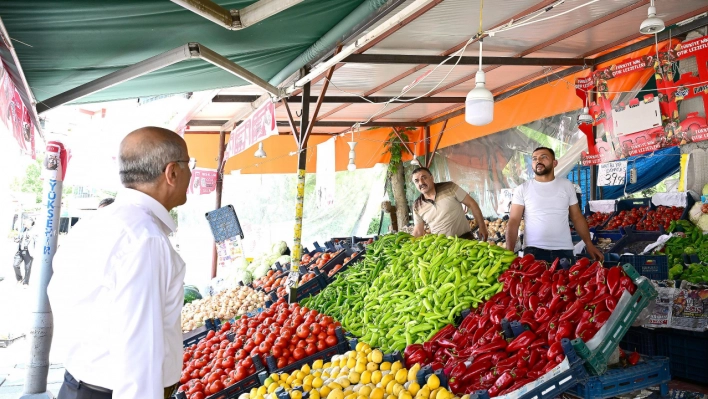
[506,147,603,264]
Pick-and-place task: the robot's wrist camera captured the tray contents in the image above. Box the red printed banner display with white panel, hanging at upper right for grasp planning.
[576,36,708,165]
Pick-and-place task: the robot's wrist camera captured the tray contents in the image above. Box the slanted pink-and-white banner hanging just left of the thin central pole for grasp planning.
[224,101,278,159]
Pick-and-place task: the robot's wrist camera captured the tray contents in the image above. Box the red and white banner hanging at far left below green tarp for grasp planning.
[0,62,37,159]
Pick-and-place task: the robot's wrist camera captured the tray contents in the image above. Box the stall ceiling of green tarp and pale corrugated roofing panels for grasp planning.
[0,0,708,138]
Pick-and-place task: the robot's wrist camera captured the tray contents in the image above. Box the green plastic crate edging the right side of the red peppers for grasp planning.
[572,264,658,375]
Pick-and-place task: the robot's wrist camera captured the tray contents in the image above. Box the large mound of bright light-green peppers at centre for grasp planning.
[303,233,516,351]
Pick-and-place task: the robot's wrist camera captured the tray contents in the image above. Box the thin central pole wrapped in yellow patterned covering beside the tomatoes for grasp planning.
[288,77,310,303]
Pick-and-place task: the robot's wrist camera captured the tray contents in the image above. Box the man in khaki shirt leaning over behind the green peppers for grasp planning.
[411,167,488,241]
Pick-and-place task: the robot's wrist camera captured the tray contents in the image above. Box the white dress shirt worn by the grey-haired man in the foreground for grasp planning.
[48,189,185,399]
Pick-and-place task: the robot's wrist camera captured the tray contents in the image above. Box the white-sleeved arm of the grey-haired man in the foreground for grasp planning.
[107,238,168,399]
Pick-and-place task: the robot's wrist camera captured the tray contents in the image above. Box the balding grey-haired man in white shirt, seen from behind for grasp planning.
[48,127,192,399]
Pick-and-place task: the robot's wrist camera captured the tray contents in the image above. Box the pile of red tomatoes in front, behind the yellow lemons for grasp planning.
[179,299,341,399]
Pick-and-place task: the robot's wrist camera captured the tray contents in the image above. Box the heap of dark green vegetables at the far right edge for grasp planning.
[663,220,708,283]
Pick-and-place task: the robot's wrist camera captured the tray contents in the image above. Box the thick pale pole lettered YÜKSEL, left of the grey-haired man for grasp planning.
[21,141,66,399]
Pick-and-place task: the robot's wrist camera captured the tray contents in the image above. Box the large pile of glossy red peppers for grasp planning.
[404,255,636,397]
